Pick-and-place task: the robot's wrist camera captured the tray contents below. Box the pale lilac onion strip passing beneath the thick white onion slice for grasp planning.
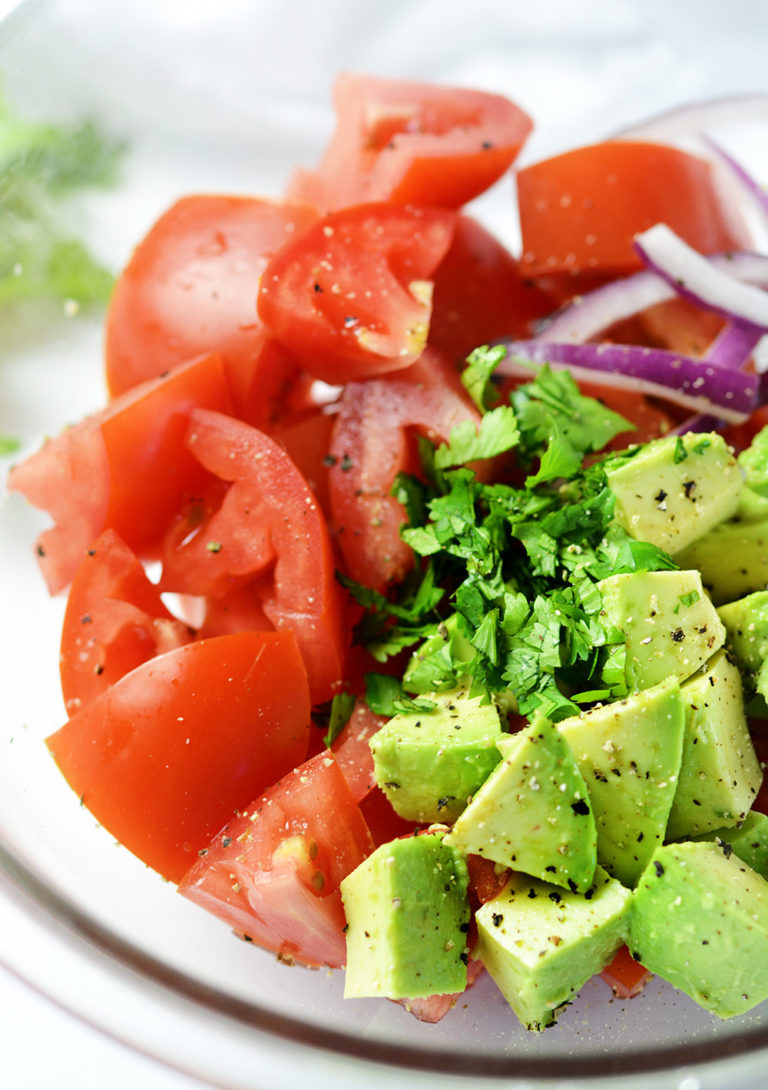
[536,252,768,344]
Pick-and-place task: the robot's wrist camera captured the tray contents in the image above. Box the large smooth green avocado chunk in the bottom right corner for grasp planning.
[627,840,768,1018]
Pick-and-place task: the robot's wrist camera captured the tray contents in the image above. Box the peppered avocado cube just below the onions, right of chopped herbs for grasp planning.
[606,432,743,556]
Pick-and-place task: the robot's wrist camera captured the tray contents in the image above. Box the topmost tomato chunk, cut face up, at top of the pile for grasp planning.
[290,73,533,210]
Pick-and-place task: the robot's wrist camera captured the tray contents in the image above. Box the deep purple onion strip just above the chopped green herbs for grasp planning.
[498,340,760,423]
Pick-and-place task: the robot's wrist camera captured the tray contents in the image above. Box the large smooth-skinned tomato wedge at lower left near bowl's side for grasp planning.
[48,632,309,882]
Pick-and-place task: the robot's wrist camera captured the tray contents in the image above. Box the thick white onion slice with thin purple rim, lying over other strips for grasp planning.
[634,223,768,332]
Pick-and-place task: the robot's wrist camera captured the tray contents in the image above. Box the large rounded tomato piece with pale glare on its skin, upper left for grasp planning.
[106,195,317,420]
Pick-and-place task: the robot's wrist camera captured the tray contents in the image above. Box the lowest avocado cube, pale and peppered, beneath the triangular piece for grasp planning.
[475,867,632,1030]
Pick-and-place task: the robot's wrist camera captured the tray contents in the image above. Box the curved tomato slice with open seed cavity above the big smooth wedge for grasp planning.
[160,411,348,704]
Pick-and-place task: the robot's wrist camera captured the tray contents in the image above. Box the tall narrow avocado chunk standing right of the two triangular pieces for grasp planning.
[667,651,763,840]
